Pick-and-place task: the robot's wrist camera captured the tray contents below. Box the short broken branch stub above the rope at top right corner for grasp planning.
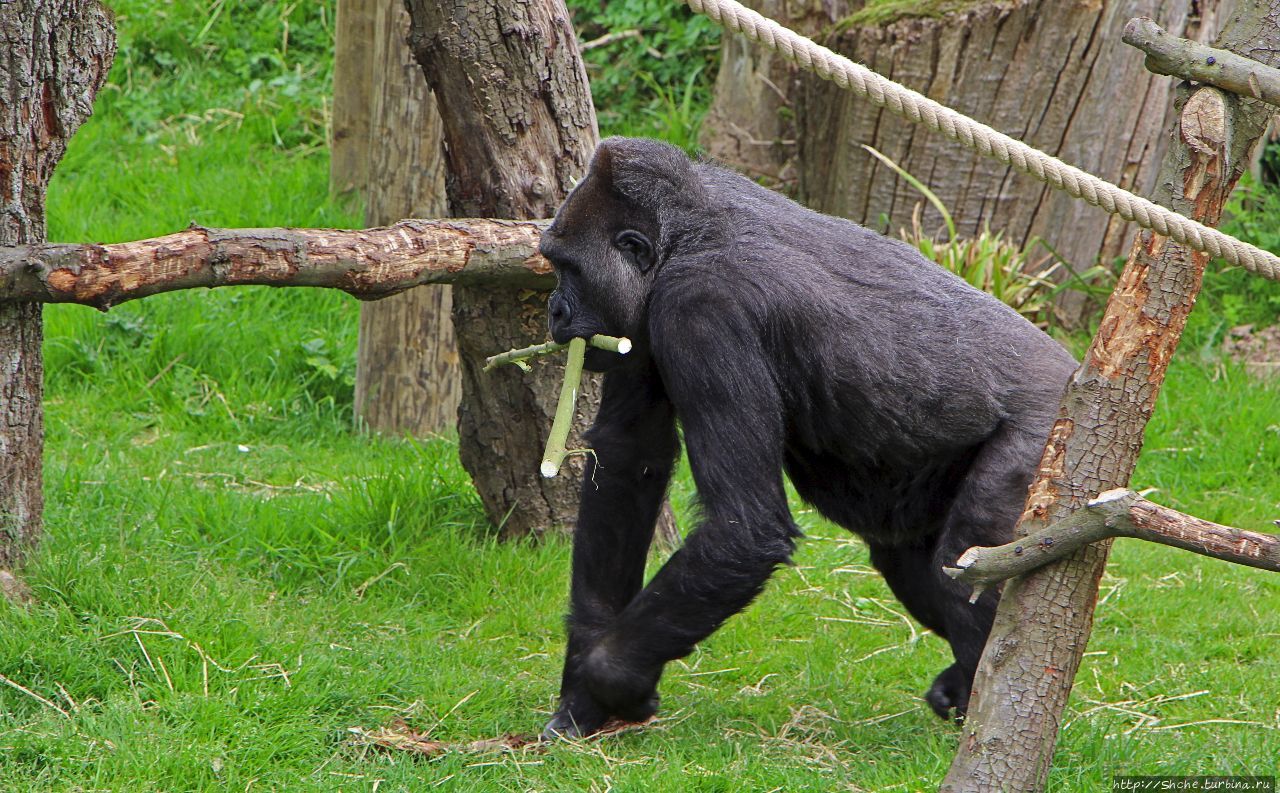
[1124,17,1280,105]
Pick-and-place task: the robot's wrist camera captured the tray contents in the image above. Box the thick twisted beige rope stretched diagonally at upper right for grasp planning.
[682,0,1280,280]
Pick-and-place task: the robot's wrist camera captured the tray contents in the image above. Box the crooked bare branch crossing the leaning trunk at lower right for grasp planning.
[942,489,1280,600]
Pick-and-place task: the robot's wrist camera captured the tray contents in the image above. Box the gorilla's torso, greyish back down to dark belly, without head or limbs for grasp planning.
[698,158,1075,530]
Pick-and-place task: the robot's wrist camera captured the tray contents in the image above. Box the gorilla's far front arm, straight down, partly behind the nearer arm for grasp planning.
[543,371,678,737]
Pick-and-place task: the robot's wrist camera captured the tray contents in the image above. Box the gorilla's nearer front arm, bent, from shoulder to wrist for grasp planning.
[582,303,799,718]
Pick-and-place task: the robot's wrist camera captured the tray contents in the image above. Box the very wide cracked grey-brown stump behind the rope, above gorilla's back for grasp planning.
[797,0,1234,285]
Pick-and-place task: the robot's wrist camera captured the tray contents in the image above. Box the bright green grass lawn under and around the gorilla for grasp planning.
[0,0,1280,793]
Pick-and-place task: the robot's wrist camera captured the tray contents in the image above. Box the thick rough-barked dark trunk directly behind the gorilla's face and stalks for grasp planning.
[407,0,599,536]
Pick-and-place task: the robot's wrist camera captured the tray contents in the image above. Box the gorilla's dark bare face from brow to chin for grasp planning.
[539,149,658,371]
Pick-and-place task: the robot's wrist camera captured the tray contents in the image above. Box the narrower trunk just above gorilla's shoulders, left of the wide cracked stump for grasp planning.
[701,0,863,192]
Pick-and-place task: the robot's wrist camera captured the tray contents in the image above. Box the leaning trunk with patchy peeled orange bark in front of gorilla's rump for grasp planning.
[942,0,1280,792]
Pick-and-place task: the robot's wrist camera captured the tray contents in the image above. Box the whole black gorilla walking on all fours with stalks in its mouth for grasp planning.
[540,138,1075,737]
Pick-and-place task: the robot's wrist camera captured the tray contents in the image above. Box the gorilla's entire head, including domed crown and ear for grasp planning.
[539,138,703,370]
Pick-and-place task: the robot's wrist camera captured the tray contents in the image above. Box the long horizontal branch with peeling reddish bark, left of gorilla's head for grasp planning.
[0,220,554,311]
